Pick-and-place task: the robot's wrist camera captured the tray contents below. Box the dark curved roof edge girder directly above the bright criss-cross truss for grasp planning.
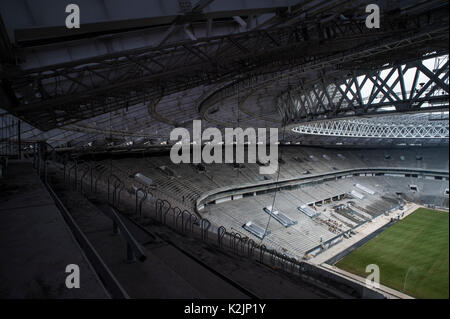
[198,6,448,117]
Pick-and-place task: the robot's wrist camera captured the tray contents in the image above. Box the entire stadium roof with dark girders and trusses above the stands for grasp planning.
[0,0,449,146]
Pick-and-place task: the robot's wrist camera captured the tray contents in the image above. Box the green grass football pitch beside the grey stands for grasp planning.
[335,208,449,298]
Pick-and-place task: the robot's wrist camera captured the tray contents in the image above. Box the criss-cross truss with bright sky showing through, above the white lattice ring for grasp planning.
[277,55,449,123]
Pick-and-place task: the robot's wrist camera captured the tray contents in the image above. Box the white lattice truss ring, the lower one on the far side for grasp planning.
[292,113,449,139]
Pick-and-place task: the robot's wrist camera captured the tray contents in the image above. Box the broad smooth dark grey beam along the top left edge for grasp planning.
[0,0,288,46]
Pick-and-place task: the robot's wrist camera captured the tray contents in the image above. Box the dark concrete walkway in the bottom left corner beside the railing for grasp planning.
[0,161,109,298]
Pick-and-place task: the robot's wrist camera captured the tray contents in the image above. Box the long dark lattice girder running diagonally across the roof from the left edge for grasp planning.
[0,1,448,130]
